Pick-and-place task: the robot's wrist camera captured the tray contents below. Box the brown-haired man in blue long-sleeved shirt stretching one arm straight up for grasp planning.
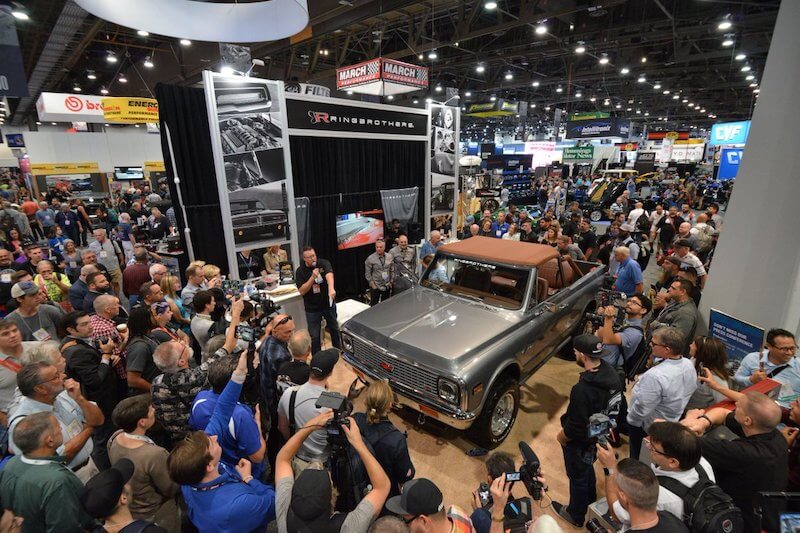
[167,352,275,533]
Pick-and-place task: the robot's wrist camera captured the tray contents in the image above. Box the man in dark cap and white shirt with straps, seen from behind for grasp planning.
[278,348,339,476]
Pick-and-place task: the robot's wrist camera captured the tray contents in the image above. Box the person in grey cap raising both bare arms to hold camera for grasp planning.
[275,411,389,533]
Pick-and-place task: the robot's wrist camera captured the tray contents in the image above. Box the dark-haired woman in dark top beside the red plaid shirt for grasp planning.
[125,307,170,395]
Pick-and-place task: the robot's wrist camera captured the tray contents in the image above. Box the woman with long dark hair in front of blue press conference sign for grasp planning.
[686,336,730,410]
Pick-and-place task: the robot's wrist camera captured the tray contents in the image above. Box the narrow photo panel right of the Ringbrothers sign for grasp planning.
[425,104,460,238]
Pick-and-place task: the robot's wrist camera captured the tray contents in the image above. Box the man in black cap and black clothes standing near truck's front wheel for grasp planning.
[553,334,625,528]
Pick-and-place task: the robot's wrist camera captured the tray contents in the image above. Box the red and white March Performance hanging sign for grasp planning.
[336,57,428,96]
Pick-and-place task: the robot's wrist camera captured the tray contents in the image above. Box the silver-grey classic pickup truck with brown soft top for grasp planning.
[342,237,605,448]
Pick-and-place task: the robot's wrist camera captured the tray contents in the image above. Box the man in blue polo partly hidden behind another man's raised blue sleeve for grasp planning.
[189,357,267,479]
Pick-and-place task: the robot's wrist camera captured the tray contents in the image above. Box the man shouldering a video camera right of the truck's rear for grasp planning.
[595,292,653,368]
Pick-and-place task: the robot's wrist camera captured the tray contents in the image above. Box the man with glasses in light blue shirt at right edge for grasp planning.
[733,329,800,396]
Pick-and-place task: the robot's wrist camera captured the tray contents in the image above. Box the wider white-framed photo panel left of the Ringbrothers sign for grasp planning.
[203,71,296,277]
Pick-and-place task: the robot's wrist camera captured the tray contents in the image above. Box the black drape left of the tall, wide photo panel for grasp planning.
[156,83,228,278]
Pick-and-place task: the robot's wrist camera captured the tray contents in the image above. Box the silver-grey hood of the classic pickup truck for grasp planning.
[344,286,519,360]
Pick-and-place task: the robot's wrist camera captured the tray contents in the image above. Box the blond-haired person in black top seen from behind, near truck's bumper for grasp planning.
[353,381,414,498]
